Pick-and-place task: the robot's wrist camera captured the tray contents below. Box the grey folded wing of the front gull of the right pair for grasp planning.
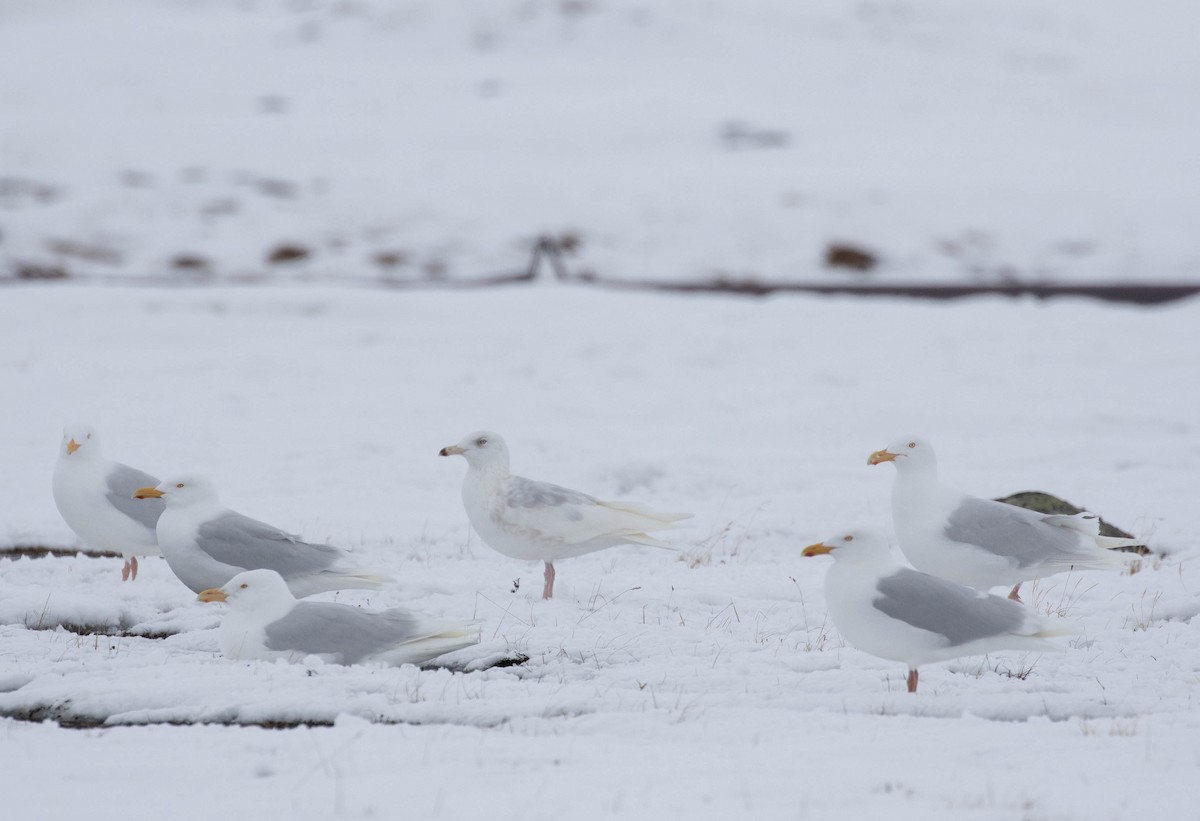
[872,568,1027,647]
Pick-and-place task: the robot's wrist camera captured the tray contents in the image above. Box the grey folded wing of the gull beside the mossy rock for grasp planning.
[946,497,1080,568]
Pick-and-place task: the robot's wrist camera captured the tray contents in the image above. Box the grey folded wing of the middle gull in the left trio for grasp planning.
[196,510,342,579]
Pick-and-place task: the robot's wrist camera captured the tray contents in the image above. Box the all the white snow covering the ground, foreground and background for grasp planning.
[0,0,1200,821]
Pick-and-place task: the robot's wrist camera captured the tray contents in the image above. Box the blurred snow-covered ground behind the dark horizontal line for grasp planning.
[0,0,1200,282]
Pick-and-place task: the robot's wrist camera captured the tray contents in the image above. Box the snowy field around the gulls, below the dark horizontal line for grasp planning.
[0,286,1200,821]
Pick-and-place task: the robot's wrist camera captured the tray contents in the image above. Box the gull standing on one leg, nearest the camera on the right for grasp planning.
[803,529,1079,693]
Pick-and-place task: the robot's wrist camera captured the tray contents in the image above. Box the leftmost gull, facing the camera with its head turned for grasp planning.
[52,425,163,581]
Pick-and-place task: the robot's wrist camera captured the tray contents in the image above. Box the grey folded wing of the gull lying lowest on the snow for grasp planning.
[265,601,422,664]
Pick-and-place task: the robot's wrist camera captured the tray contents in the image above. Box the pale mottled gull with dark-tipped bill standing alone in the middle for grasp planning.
[440,431,691,599]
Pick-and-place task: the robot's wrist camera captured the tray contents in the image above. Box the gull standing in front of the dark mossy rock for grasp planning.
[866,436,1142,601]
